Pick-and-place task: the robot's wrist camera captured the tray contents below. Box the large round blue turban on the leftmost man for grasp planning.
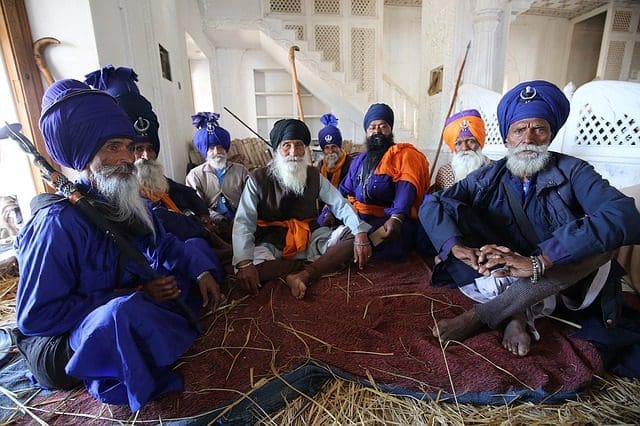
[40,80,135,170]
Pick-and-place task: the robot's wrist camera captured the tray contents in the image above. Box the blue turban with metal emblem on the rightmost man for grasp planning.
[498,80,569,142]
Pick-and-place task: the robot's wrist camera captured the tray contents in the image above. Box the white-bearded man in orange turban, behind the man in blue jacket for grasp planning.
[431,109,491,192]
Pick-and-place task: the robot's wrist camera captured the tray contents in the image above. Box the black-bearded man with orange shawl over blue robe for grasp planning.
[328,104,429,259]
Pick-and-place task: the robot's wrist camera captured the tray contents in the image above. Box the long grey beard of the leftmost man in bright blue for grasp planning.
[93,164,156,238]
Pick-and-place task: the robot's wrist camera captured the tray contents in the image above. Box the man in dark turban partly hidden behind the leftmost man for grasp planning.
[86,65,231,263]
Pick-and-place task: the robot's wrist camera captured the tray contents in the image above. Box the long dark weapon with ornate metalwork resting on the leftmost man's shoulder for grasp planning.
[0,122,202,334]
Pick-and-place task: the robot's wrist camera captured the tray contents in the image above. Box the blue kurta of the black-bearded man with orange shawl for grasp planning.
[338,152,416,259]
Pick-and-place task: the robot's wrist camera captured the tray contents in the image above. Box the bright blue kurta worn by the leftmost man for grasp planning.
[16,184,217,411]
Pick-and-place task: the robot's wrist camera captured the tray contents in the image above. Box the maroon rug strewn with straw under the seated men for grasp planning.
[22,259,602,424]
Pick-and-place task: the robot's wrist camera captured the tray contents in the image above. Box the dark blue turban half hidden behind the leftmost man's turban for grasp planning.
[85,65,160,154]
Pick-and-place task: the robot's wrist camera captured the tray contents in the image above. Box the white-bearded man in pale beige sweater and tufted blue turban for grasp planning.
[186,112,249,241]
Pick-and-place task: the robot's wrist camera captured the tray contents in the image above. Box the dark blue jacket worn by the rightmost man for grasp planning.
[420,152,640,264]
